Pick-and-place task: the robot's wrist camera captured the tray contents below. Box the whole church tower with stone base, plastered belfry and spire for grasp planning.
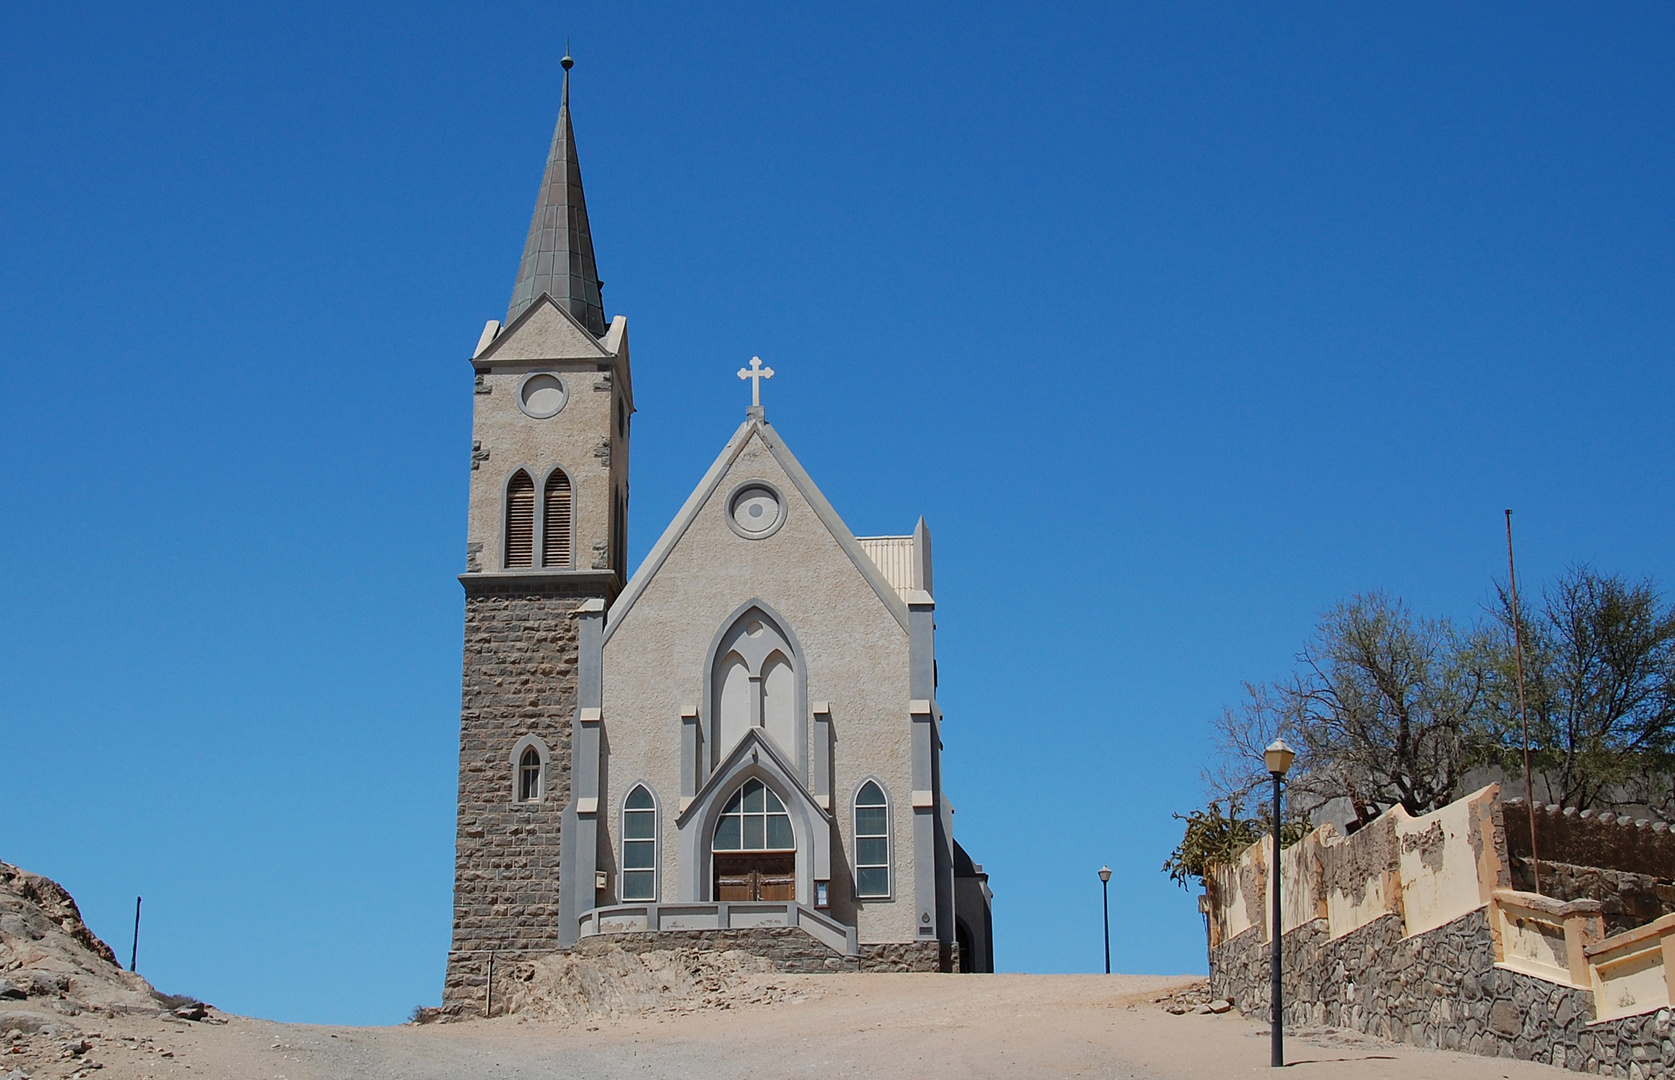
[442,55,633,1013]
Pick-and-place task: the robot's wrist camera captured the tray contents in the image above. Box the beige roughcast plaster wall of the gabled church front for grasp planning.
[601,425,930,943]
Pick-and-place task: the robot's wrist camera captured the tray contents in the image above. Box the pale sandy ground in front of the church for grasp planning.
[0,975,1559,1080]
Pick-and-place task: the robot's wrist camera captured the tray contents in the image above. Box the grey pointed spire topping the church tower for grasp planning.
[506,45,605,337]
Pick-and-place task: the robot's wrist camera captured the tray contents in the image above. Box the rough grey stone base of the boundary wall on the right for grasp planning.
[1209,909,1675,1080]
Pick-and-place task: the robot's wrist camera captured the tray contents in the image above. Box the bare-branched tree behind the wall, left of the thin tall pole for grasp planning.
[1208,593,1486,824]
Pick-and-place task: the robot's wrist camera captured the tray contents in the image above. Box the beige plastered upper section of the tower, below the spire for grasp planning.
[466,308,628,576]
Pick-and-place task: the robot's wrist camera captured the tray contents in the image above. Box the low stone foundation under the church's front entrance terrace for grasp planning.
[570,926,960,975]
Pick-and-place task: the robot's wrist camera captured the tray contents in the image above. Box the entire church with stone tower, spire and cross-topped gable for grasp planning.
[444,55,993,1010]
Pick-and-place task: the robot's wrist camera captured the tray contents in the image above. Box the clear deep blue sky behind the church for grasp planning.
[0,3,1675,1023]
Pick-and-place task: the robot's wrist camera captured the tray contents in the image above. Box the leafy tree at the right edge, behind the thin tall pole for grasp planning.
[1482,564,1675,817]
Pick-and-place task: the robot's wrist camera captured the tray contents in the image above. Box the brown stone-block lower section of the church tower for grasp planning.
[442,584,583,1006]
